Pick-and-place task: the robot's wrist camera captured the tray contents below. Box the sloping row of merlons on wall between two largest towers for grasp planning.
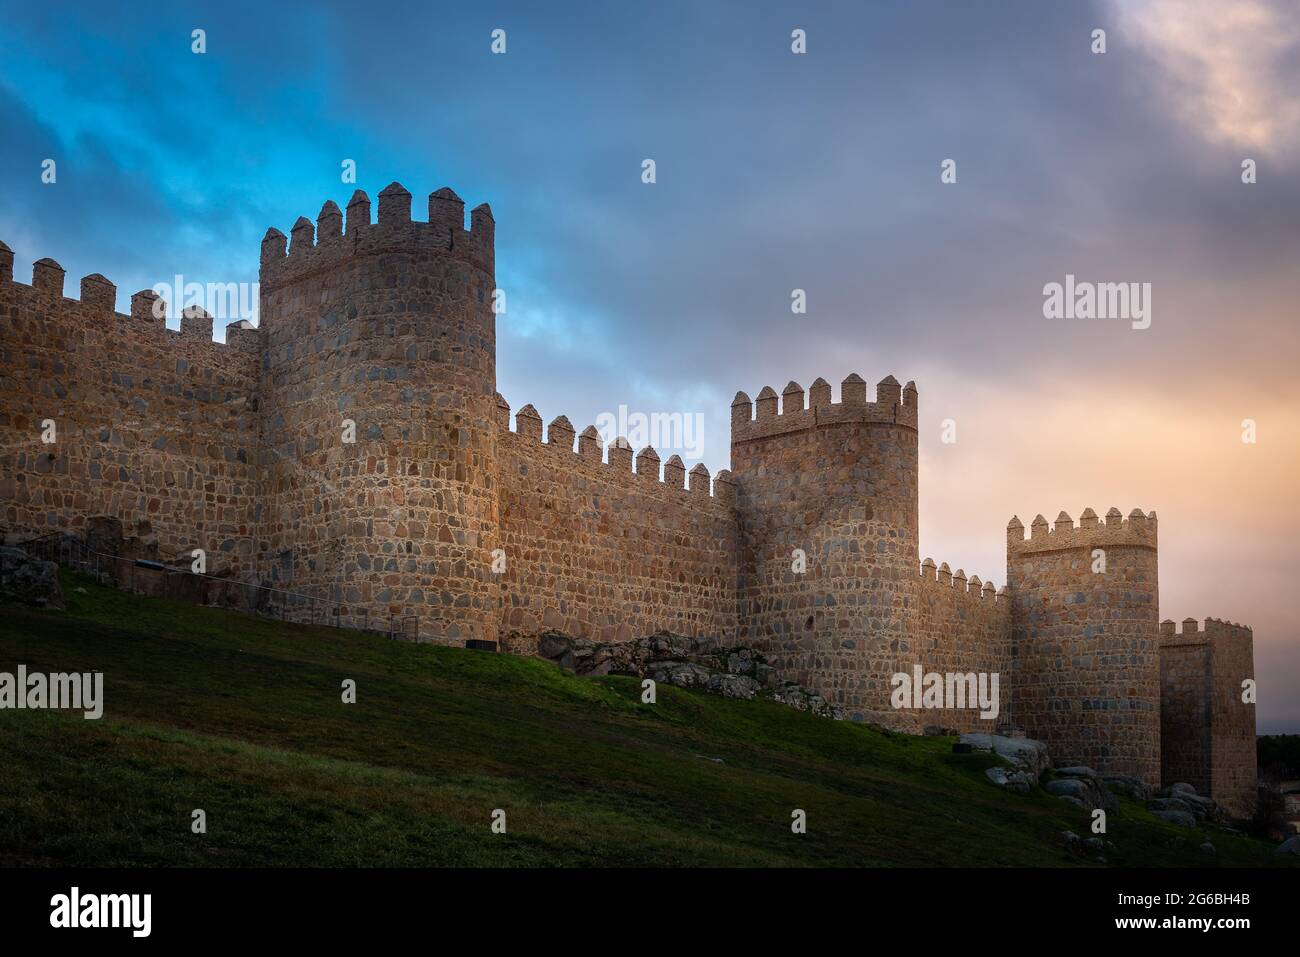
[497,393,736,508]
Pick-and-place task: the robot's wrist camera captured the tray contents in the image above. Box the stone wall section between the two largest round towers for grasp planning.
[498,400,737,654]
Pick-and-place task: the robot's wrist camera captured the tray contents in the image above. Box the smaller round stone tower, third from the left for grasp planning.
[1006,508,1160,787]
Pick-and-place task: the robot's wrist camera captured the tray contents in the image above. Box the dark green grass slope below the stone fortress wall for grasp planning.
[0,575,1288,867]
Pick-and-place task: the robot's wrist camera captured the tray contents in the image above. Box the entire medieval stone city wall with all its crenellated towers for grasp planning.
[0,183,1255,813]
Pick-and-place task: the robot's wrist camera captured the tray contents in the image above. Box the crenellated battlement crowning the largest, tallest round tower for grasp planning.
[261,182,497,290]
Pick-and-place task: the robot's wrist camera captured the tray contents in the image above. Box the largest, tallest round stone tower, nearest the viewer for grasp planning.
[257,183,498,644]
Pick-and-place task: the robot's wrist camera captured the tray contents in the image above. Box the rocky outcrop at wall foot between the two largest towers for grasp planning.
[537,631,846,720]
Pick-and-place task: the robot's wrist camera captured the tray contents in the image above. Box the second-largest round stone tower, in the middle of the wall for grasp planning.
[731,374,918,723]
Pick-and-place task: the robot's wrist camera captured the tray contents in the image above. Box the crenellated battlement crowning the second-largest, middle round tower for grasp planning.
[732,373,917,445]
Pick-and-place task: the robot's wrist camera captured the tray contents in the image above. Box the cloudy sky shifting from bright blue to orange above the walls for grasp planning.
[0,0,1300,732]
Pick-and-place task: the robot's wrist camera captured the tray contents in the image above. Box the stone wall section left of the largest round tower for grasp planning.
[0,244,259,576]
